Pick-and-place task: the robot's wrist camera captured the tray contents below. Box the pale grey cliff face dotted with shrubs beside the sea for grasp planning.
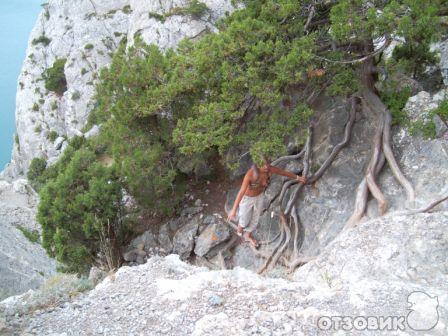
[2,0,234,180]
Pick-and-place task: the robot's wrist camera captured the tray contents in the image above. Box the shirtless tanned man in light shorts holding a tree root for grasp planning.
[227,158,306,247]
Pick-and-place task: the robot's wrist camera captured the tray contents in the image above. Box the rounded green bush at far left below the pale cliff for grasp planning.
[37,148,123,273]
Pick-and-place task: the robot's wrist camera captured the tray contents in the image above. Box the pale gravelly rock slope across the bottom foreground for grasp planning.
[0,211,448,336]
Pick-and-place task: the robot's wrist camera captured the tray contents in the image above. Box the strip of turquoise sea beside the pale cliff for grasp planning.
[0,0,42,170]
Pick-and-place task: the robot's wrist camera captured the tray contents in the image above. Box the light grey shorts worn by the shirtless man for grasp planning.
[237,192,264,232]
